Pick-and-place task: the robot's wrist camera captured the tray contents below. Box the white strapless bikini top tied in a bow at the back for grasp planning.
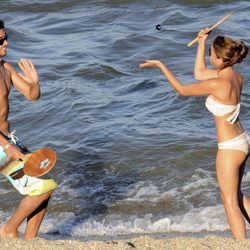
[205,95,240,124]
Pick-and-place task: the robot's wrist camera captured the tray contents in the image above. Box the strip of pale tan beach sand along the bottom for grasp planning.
[0,235,250,250]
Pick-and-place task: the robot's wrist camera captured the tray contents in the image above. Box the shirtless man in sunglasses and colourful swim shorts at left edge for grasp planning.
[0,20,57,240]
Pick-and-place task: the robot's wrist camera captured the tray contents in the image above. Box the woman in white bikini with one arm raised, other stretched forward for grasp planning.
[140,28,250,240]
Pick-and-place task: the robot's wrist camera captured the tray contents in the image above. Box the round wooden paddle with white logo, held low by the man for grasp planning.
[23,148,57,177]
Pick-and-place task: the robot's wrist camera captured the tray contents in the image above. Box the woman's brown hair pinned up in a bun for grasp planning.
[213,36,248,69]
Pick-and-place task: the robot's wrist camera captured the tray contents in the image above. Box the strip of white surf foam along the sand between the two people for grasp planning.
[37,206,234,237]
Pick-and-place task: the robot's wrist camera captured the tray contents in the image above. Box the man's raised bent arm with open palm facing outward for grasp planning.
[5,59,40,101]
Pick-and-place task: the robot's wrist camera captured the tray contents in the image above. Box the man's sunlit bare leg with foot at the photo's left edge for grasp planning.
[0,192,51,238]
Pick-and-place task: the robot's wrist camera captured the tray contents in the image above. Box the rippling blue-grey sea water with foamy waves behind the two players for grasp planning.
[0,0,250,238]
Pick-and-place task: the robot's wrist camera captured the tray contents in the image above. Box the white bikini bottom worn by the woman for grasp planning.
[218,132,250,155]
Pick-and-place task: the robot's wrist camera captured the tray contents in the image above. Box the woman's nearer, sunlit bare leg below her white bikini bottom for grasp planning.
[216,150,246,240]
